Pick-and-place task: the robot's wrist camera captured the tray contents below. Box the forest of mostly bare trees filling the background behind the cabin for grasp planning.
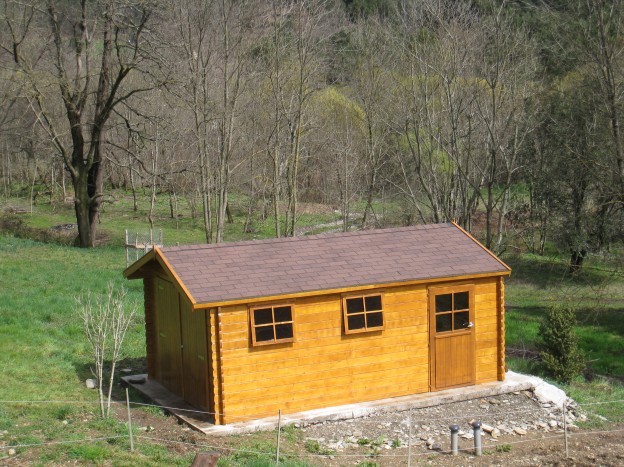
[0,0,624,269]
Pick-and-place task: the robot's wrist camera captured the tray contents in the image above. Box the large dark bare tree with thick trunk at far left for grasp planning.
[2,0,163,247]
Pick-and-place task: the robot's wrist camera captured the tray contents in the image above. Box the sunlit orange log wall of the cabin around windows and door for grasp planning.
[211,278,502,423]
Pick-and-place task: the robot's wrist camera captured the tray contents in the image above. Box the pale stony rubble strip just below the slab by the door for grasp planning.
[296,391,586,452]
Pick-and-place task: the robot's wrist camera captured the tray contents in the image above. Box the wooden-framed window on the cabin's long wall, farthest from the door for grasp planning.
[250,305,295,345]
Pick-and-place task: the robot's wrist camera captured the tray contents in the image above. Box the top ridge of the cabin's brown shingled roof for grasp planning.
[161,222,454,252]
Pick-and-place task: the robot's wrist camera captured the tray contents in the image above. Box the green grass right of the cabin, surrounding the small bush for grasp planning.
[504,250,624,426]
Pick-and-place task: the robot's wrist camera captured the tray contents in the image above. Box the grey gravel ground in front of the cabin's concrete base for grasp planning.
[296,391,600,465]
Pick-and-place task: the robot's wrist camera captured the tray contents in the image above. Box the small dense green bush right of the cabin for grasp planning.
[539,306,585,384]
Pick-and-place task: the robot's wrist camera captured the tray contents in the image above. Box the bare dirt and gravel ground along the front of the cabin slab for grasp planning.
[132,391,624,467]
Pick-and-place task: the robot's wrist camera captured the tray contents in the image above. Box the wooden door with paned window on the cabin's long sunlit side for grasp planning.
[429,285,475,391]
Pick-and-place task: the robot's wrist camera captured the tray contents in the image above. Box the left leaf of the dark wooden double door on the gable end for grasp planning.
[154,277,184,397]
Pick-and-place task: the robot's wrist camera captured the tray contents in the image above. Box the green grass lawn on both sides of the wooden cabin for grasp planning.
[0,194,624,465]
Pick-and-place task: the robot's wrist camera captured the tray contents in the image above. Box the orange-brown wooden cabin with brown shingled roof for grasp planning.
[124,223,511,424]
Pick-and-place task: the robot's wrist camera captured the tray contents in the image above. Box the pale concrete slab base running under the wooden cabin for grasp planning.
[123,371,566,435]
